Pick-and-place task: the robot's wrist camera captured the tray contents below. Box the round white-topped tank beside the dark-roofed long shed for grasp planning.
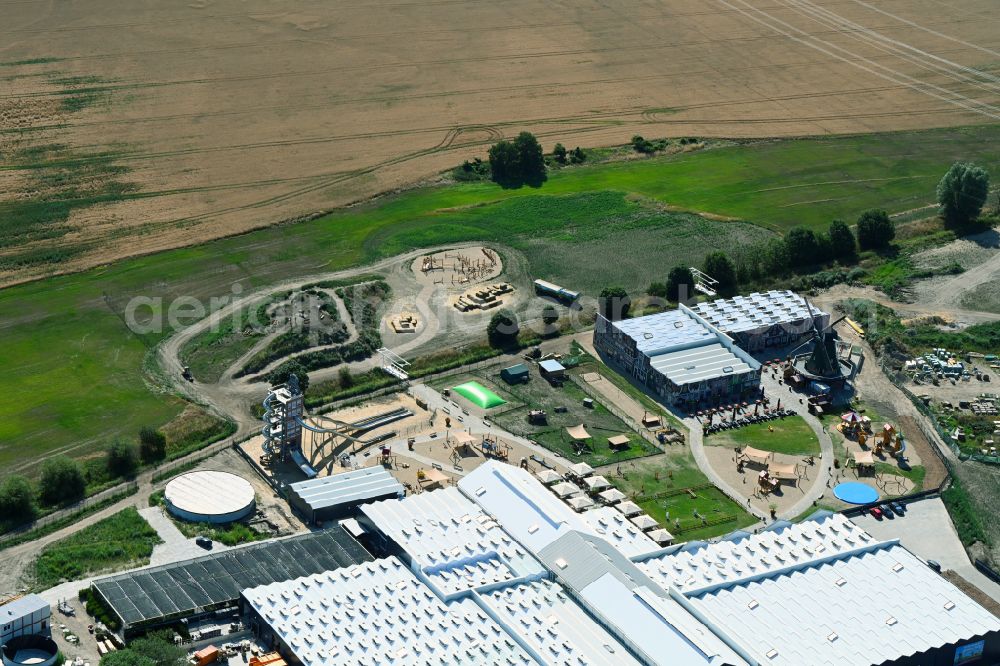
[163,472,257,523]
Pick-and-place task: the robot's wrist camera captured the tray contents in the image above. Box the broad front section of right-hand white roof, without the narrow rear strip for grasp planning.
[692,545,1000,666]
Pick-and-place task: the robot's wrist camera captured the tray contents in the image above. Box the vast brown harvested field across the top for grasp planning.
[0,0,1000,283]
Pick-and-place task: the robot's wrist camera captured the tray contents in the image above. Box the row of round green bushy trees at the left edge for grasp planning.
[0,428,167,525]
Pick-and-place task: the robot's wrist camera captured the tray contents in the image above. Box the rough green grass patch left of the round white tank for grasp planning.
[34,507,163,590]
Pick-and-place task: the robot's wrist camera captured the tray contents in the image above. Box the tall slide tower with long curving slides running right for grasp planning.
[260,375,413,479]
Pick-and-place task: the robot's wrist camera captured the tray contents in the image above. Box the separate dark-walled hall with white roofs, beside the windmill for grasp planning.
[594,291,830,406]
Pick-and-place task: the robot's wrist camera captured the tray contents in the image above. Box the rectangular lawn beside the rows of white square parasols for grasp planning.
[608,447,757,541]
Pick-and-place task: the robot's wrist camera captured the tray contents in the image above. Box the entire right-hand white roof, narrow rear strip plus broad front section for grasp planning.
[637,514,1000,666]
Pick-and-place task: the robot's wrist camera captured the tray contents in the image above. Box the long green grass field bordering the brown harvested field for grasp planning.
[0,125,1000,474]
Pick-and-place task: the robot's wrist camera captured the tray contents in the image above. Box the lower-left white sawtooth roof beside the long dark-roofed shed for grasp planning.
[243,557,534,666]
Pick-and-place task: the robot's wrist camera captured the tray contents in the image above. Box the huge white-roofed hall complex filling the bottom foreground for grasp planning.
[243,461,1000,666]
